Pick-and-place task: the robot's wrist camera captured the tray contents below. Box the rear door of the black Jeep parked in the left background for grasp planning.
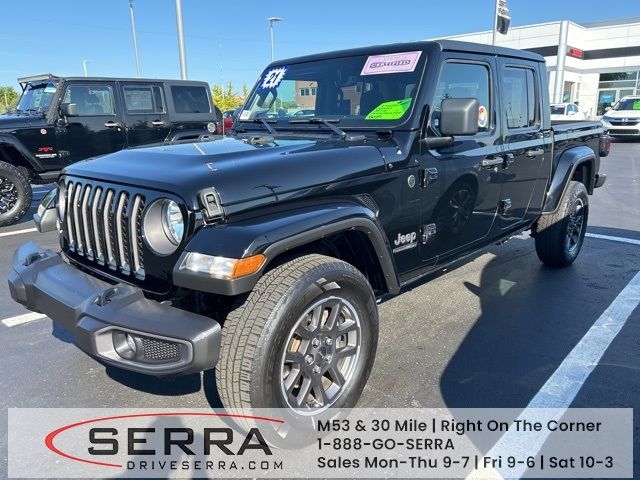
[120,82,171,147]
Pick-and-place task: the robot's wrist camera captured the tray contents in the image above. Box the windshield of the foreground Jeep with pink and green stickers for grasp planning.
[239,51,425,128]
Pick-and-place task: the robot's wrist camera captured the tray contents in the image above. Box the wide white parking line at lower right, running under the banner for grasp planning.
[467,272,640,478]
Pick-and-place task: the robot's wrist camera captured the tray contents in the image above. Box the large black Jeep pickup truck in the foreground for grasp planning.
[9,41,609,415]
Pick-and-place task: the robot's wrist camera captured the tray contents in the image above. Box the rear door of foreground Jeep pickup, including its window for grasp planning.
[498,58,551,229]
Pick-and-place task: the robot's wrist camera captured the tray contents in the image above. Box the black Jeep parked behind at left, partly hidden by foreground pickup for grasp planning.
[0,74,220,227]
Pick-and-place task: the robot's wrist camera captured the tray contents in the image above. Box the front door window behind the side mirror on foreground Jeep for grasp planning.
[431,62,493,132]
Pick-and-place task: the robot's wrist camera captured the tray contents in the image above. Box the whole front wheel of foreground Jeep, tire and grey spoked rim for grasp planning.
[216,255,378,415]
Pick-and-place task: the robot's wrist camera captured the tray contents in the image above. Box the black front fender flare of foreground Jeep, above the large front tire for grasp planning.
[173,201,400,295]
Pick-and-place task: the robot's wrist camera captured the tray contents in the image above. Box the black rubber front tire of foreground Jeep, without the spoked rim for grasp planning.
[216,254,378,412]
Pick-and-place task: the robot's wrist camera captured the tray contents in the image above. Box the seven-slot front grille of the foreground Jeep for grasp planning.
[63,180,145,278]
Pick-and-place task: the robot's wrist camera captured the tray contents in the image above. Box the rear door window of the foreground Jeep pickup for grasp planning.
[502,67,538,129]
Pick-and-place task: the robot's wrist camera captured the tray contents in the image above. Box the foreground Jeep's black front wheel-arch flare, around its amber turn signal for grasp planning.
[173,201,400,295]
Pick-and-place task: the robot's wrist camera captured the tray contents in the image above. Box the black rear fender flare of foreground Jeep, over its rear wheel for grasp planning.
[542,145,596,214]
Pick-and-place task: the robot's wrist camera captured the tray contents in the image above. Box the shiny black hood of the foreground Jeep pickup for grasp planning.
[64,138,388,209]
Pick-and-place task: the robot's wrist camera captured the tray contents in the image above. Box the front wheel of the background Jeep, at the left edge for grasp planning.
[0,161,33,227]
